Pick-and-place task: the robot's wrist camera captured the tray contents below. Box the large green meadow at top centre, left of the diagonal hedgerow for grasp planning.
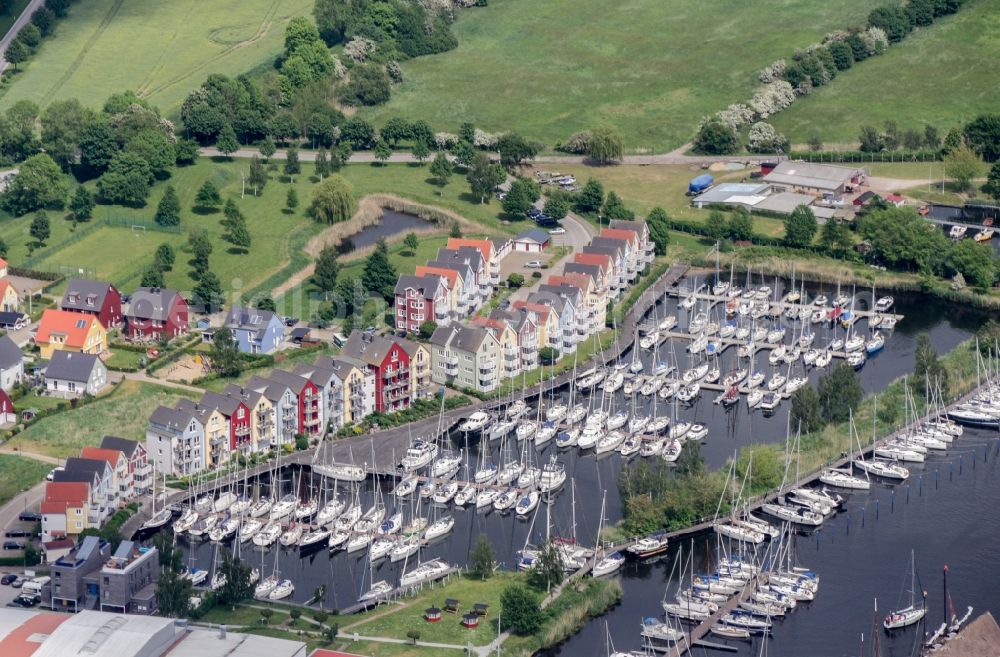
[363,0,884,152]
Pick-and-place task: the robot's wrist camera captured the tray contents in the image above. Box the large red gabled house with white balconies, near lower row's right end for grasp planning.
[341,331,412,413]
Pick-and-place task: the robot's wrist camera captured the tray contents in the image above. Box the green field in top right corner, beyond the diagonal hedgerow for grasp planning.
[774,0,1000,143]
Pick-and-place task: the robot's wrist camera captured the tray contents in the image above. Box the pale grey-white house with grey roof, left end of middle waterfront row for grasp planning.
[146,405,207,477]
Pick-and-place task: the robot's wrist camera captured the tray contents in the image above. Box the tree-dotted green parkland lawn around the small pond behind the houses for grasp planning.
[0,158,516,302]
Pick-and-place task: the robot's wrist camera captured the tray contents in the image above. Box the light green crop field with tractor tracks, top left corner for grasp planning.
[0,0,312,113]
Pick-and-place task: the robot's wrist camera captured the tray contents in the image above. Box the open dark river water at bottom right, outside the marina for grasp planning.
[547,430,1000,657]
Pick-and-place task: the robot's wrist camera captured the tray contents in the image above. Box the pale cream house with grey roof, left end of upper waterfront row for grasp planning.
[431,324,501,392]
